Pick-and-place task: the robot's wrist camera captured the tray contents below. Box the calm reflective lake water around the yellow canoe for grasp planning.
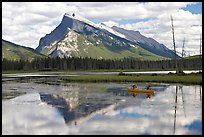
[2,73,202,135]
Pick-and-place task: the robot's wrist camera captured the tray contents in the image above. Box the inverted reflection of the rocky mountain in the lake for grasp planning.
[39,84,169,125]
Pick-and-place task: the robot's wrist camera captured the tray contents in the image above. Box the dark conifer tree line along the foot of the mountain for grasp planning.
[2,57,202,70]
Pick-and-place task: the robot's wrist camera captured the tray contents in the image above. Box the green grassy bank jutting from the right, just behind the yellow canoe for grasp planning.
[62,74,202,85]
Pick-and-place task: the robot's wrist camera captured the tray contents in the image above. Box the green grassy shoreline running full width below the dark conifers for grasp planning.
[2,70,202,85]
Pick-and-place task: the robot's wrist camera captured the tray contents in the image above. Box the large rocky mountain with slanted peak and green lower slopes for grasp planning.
[36,14,178,60]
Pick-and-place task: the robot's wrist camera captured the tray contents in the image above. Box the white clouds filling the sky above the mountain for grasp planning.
[2,2,202,53]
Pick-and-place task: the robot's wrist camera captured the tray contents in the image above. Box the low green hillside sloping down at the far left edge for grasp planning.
[2,39,45,60]
